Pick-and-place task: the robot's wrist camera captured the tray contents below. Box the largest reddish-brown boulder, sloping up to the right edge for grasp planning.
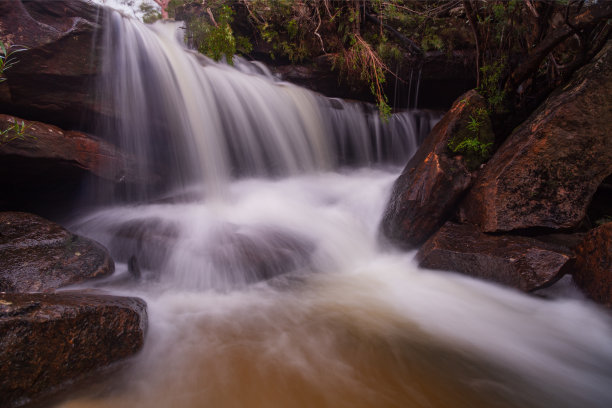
[461,41,612,232]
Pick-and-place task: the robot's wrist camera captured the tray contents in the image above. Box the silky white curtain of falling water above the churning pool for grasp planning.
[98,12,437,202]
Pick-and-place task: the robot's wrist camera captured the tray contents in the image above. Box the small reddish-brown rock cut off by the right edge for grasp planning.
[573,223,612,307]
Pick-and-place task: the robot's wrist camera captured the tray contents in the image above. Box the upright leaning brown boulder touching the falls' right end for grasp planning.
[381,91,490,247]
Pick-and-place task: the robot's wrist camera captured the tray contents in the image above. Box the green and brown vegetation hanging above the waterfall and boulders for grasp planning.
[130,0,612,124]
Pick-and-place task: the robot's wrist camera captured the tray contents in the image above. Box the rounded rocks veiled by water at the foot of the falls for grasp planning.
[109,217,315,289]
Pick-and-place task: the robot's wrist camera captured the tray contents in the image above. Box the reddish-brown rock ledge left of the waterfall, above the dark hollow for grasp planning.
[0,114,136,182]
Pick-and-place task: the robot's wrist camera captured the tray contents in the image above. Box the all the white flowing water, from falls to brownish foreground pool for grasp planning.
[61,8,612,408]
